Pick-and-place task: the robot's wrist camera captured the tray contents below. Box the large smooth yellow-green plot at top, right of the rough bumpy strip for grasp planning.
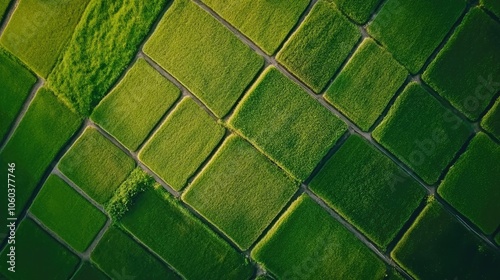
[144,0,264,118]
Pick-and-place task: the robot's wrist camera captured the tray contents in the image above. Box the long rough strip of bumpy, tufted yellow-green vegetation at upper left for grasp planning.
[48,0,168,116]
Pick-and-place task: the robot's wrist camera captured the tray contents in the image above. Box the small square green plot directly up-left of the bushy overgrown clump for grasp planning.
[58,127,135,204]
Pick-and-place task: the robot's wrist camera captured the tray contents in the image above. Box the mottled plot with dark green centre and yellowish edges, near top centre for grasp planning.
[276,0,361,93]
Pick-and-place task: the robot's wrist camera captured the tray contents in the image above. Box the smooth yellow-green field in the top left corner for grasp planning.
[0,0,89,77]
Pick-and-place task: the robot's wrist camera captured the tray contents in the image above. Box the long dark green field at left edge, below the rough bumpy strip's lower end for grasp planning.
[0,88,81,223]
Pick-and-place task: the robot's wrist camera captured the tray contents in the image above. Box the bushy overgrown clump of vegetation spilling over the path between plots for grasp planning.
[106,167,156,221]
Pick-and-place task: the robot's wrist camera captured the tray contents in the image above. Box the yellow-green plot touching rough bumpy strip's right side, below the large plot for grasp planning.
[91,58,180,151]
